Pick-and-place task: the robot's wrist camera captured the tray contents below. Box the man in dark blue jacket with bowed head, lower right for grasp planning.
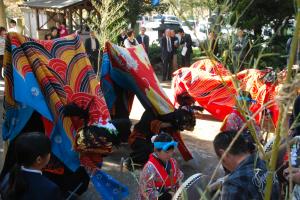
[213,131,280,200]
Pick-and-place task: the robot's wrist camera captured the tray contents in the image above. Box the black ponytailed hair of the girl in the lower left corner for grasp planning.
[7,132,51,200]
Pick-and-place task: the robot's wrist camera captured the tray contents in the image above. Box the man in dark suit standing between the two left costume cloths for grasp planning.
[84,31,100,73]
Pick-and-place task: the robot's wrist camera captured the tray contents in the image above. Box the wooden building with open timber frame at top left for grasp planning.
[20,0,93,39]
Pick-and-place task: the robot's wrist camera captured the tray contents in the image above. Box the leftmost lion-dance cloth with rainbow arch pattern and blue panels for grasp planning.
[2,33,111,170]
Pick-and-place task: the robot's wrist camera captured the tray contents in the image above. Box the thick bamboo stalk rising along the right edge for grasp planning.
[264,0,300,200]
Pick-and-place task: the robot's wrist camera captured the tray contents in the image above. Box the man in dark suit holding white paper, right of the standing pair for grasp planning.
[178,28,193,67]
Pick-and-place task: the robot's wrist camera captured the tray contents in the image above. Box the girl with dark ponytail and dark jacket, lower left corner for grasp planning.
[5,132,62,200]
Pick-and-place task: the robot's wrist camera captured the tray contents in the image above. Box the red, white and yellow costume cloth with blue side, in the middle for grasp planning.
[101,42,192,160]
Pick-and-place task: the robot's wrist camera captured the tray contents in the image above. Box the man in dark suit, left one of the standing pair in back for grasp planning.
[161,29,174,81]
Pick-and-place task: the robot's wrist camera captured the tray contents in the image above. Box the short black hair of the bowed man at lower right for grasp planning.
[213,131,255,157]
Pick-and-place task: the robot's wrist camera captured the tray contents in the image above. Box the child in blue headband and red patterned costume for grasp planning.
[139,133,183,200]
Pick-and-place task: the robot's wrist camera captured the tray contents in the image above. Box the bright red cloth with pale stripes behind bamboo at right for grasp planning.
[172,59,279,124]
